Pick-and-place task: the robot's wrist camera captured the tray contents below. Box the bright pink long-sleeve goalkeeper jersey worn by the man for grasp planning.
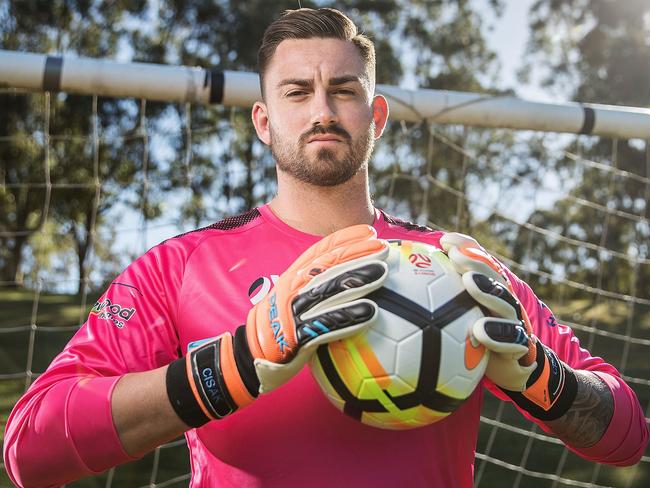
[4,206,648,488]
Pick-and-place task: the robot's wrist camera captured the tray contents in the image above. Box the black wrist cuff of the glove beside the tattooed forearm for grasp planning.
[503,342,578,421]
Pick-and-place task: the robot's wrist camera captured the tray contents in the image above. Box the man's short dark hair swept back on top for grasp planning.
[257,8,375,95]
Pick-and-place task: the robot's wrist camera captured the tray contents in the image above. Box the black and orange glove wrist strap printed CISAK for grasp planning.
[166,327,259,427]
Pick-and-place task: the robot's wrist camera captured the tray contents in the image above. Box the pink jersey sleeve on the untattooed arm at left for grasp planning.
[4,239,188,486]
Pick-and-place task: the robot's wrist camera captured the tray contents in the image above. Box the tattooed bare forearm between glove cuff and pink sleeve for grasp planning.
[546,371,614,447]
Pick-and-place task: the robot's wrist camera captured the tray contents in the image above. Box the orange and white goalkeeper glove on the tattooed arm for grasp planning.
[440,233,577,420]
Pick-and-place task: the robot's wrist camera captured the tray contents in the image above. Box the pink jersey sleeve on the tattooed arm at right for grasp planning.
[486,270,650,466]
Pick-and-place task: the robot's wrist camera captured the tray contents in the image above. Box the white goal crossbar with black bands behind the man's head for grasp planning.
[5,50,650,139]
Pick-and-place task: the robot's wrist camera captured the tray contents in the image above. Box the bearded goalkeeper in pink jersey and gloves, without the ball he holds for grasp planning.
[4,9,648,488]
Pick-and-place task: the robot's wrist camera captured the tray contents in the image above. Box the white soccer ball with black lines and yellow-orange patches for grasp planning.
[310,240,489,429]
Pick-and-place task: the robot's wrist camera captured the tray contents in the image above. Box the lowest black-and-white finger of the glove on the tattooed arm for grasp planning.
[472,317,530,359]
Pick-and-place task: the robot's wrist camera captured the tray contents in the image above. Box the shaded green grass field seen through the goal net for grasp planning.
[0,290,650,488]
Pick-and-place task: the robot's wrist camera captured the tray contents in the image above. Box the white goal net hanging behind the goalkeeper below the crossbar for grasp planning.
[0,53,650,488]
